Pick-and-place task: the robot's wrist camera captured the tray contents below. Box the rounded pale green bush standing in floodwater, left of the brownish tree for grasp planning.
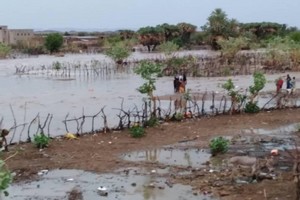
[105,42,130,63]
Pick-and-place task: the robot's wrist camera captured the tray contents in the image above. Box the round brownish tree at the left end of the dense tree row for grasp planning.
[138,26,164,52]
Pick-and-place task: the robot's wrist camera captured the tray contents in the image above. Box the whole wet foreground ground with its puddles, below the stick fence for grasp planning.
[5,109,300,200]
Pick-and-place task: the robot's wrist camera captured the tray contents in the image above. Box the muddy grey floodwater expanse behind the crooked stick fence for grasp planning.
[0,51,300,140]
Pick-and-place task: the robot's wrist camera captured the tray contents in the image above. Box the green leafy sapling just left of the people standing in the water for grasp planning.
[134,61,161,98]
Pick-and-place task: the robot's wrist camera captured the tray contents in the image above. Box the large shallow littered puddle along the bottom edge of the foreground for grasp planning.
[4,169,213,200]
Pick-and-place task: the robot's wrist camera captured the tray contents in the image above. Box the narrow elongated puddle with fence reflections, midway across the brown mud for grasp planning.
[122,148,211,168]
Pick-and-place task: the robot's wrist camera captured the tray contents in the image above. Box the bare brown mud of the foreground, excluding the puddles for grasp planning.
[4,109,300,200]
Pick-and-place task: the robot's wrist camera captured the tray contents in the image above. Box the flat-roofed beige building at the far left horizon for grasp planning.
[0,26,34,45]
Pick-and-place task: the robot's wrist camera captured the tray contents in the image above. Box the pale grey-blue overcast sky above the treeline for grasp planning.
[0,0,300,30]
